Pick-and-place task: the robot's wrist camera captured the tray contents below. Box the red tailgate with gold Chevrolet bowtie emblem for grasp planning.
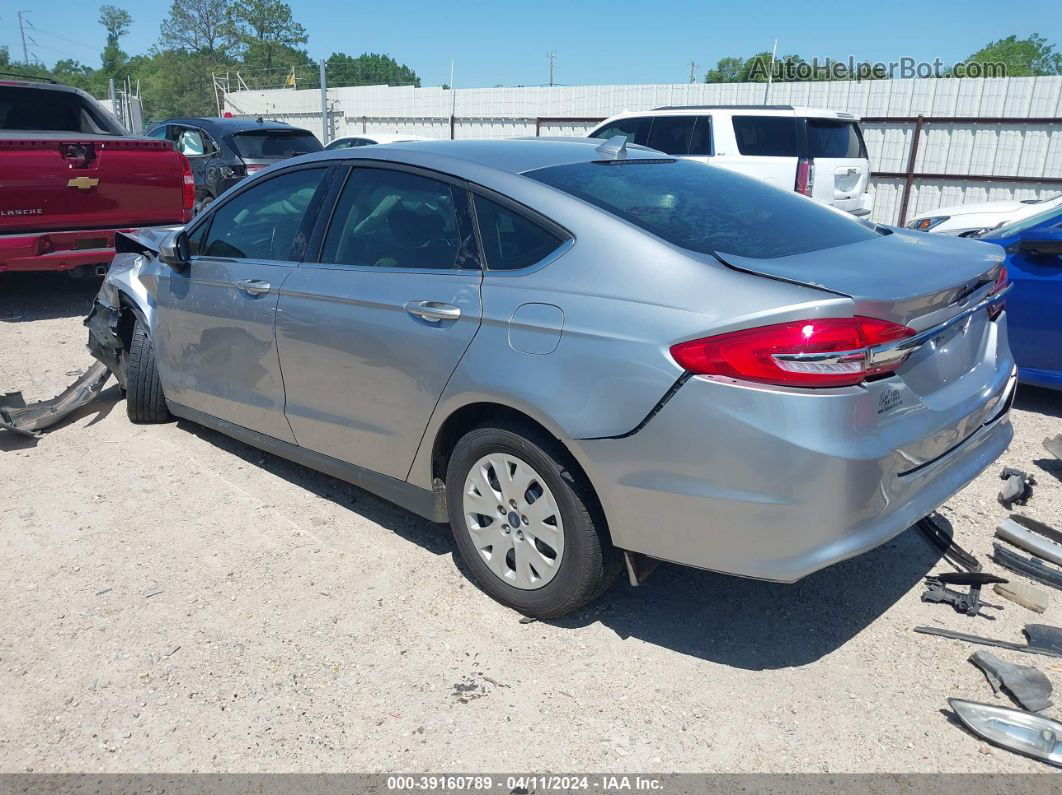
[0,132,184,235]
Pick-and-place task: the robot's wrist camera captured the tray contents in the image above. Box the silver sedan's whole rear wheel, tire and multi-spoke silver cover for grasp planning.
[446,426,621,618]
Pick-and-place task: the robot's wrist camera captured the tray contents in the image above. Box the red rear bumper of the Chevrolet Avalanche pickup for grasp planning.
[0,229,127,272]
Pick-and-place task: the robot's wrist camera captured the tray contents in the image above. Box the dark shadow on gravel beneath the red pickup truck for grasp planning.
[0,273,102,323]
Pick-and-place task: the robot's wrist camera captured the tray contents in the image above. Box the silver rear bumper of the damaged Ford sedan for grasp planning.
[578,353,1016,582]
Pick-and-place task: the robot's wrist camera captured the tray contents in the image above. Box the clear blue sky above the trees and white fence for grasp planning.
[0,0,1062,88]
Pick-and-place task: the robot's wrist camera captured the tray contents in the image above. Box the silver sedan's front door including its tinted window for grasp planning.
[152,167,327,442]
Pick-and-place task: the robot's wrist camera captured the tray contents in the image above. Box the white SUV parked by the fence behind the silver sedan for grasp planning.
[589,105,871,215]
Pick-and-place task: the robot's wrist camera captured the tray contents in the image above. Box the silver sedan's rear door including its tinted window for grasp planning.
[276,161,482,479]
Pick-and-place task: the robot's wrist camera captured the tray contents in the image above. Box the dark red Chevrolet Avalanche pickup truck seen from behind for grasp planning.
[0,77,195,273]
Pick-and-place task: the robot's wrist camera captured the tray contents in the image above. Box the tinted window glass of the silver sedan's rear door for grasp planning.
[321,168,479,270]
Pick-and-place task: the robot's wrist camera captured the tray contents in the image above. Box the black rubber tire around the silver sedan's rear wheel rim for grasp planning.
[446,424,622,619]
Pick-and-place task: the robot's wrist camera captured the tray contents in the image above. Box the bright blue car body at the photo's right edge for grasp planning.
[999,210,1062,382]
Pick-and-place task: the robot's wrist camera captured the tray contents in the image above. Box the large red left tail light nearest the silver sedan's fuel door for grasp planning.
[671,316,915,386]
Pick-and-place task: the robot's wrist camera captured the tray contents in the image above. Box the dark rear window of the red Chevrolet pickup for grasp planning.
[0,86,124,135]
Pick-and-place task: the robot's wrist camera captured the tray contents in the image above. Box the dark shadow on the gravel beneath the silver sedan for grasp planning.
[179,420,940,670]
